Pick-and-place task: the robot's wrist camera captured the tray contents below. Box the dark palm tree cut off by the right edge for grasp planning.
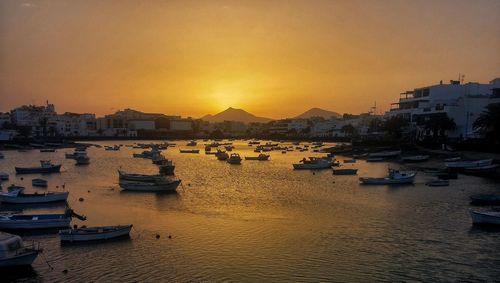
[472,103,500,143]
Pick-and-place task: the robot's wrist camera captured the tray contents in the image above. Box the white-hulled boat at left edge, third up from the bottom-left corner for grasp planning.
[0,186,69,204]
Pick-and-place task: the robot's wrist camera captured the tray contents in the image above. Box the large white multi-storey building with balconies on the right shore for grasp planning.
[386,78,500,139]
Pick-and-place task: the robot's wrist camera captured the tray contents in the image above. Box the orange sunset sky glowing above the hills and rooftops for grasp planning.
[0,0,500,118]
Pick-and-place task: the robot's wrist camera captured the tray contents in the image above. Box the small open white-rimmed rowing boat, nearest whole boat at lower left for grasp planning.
[59,224,132,242]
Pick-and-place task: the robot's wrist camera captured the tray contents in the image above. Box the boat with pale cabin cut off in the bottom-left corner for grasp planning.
[0,232,42,267]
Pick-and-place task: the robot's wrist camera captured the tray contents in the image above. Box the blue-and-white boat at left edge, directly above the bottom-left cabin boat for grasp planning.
[0,214,71,229]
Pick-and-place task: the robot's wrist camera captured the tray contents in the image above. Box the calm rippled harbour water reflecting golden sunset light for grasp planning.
[0,142,500,282]
